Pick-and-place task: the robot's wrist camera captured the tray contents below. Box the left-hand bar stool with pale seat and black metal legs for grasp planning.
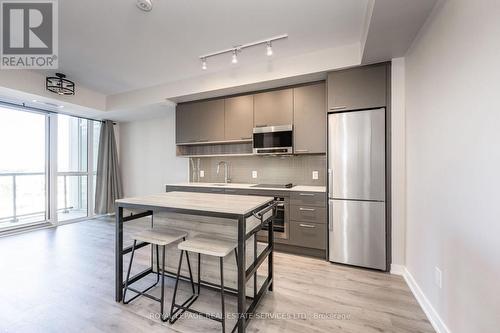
[123,227,195,321]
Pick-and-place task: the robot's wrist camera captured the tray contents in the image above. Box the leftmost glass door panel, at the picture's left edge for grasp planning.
[0,106,49,231]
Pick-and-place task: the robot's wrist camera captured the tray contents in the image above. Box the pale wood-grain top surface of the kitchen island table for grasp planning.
[116,192,274,215]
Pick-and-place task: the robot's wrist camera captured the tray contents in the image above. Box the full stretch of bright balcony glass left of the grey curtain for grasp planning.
[0,104,101,232]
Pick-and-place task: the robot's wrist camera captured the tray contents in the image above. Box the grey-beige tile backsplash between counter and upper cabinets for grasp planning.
[189,155,326,186]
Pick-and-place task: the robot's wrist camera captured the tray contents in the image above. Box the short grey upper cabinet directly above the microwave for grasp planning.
[254,89,293,127]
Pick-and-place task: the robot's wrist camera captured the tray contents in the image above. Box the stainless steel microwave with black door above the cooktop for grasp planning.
[253,125,293,154]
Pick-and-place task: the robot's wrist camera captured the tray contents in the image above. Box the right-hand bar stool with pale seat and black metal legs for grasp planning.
[170,235,238,332]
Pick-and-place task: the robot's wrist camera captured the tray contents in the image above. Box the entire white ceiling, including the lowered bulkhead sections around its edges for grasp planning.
[0,0,439,120]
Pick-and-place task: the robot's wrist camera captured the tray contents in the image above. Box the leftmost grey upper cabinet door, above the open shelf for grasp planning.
[176,99,224,143]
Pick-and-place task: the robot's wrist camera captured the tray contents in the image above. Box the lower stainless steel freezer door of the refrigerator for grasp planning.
[328,200,386,270]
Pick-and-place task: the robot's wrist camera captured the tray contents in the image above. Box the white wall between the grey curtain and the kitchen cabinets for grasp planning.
[120,108,188,196]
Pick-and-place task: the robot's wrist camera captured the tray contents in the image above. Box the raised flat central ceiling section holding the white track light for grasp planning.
[52,0,370,95]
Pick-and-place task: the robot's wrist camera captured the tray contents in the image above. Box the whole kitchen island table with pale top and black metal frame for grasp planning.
[115,192,275,332]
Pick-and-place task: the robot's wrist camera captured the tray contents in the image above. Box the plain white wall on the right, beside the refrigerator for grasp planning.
[406,0,500,333]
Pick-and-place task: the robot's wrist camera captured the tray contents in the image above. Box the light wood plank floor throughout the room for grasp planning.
[0,218,434,333]
